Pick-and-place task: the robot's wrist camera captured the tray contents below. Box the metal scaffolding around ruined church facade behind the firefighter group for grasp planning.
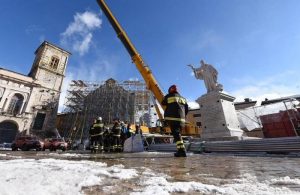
[57,78,155,140]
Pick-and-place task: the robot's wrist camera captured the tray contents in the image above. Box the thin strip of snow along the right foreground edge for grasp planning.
[131,170,300,195]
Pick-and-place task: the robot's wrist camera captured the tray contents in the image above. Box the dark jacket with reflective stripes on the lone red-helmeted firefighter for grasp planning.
[162,93,188,123]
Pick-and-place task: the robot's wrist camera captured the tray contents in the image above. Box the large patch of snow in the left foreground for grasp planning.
[0,159,137,195]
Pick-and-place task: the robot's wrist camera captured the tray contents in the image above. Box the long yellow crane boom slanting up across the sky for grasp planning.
[97,0,164,104]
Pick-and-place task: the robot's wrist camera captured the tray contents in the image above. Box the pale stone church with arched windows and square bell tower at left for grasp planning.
[0,41,70,143]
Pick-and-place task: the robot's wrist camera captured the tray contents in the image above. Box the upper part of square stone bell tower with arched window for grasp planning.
[28,41,71,92]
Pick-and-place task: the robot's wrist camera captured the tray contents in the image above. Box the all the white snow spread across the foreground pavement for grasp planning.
[0,158,300,195]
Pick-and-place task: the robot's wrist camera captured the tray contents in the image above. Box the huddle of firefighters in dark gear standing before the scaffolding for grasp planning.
[89,117,141,153]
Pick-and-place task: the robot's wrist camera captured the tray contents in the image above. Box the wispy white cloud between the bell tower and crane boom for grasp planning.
[60,11,102,56]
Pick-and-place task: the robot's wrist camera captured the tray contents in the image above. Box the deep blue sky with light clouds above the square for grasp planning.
[0,0,300,110]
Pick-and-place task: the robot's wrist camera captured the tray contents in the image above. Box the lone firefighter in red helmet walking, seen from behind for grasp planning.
[162,85,188,157]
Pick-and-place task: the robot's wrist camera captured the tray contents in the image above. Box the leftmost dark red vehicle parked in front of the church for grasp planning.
[11,135,44,151]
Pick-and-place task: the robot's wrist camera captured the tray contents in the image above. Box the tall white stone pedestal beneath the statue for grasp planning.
[196,91,243,140]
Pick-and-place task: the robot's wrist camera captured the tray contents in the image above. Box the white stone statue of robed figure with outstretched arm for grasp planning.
[188,60,223,93]
